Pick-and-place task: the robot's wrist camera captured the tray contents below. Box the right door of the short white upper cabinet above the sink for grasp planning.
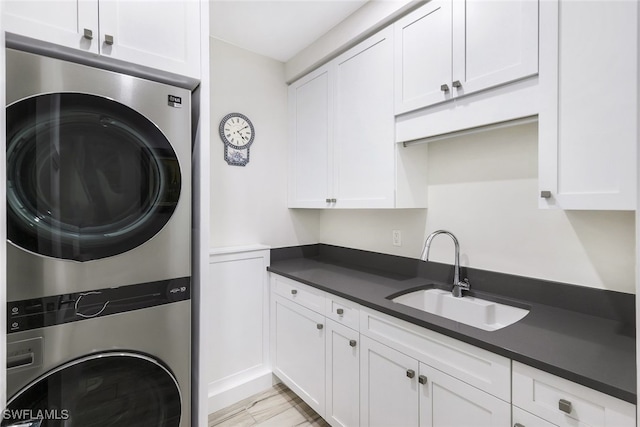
[452,0,538,96]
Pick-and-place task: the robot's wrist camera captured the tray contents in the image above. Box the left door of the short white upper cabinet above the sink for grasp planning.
[394,0,452,114]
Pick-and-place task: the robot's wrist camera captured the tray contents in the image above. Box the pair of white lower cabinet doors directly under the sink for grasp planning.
[360,336,511,427]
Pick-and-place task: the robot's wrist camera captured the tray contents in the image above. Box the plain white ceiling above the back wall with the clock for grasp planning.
[210,0,368,62]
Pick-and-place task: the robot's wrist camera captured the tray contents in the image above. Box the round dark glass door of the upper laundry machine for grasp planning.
[7,93,181,261]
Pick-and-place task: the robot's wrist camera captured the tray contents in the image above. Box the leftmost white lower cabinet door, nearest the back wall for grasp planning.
[271,295,325,417]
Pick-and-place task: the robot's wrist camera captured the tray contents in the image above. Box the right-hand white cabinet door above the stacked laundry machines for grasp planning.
[99,0,200,77]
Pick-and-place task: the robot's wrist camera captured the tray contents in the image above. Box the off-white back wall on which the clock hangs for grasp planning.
[209,38,318,251]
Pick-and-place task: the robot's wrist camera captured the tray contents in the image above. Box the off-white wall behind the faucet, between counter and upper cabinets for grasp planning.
[319,124,635,293]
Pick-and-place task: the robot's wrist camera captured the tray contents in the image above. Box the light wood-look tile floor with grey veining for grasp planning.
[208,383,330,427]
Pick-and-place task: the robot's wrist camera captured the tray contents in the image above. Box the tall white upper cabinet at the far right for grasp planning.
[539,0,638,210]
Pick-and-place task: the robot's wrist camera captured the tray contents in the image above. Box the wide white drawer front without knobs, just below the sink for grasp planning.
[360,308,511,402]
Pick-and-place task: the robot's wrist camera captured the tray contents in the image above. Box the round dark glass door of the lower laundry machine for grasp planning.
[0,353,181,427]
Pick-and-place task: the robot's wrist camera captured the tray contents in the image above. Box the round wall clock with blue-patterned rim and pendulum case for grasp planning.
[218,113,255,166]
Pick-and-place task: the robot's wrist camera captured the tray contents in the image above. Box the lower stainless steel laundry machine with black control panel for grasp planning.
[0,277,191,427]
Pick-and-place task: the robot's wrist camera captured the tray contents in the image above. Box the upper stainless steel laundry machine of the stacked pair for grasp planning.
[6,49,191,301]
